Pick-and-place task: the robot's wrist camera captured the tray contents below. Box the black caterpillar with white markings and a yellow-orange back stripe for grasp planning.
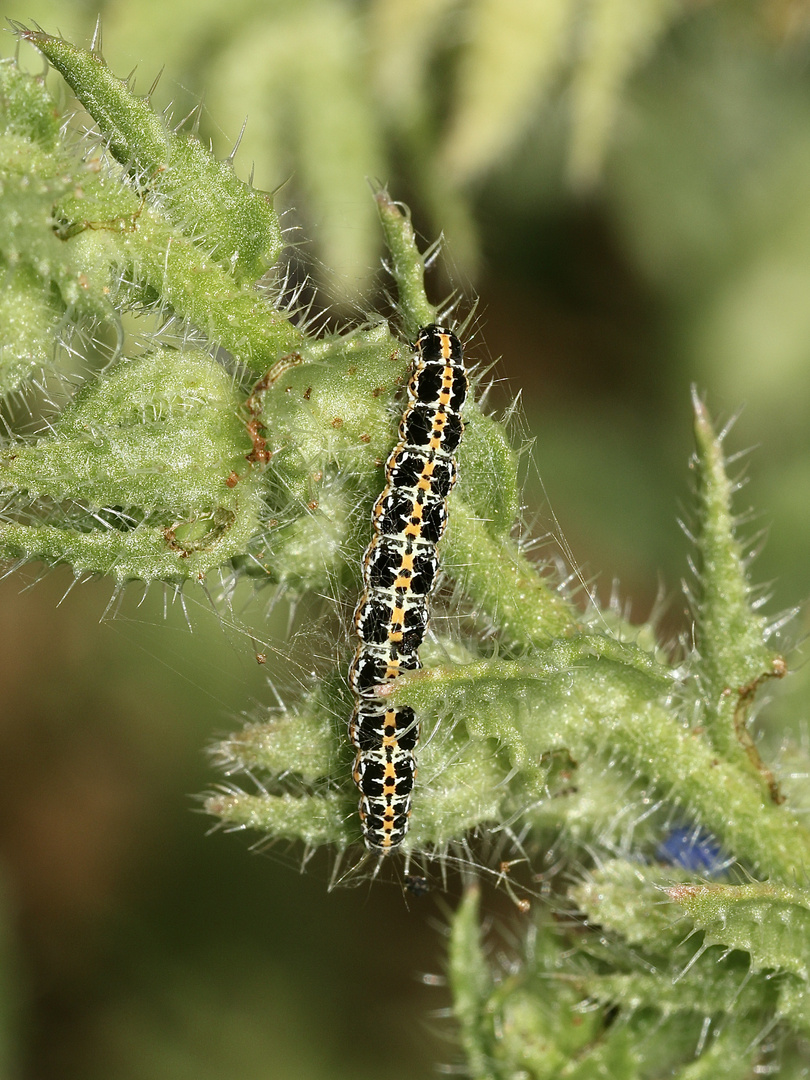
[349,325,468,854]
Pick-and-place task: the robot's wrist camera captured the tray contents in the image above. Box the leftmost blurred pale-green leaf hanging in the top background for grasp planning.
[205,0,387,301]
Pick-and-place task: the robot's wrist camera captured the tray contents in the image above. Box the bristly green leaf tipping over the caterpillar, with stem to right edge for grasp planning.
[391,635,810,880]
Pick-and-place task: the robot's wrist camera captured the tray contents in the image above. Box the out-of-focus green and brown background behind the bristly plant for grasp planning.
[0,0,810,1080]
